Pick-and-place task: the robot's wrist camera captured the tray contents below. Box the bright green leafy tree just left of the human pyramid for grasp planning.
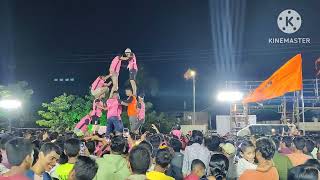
[36,94,93,131]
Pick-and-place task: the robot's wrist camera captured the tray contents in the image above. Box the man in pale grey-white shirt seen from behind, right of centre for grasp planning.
[182,130,210,176]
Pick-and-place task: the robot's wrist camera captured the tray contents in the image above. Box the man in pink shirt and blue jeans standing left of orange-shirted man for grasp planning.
[106,91,123,138]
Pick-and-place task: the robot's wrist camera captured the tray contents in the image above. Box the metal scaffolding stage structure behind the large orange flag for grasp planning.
[225,79,320,133]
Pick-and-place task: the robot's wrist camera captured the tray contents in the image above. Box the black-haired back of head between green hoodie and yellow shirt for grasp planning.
[129,146,151,174]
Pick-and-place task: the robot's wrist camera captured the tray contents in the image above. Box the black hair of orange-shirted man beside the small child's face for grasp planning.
[256,138,276,160]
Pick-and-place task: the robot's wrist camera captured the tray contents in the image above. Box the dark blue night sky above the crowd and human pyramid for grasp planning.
[0,0,320,115]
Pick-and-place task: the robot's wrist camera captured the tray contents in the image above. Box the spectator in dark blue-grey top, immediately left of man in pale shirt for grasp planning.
[167,138,183,180]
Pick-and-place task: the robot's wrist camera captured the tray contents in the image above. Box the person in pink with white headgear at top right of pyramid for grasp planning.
[124,48,138,96]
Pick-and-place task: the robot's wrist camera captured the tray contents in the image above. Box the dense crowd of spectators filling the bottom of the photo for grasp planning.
[0,126,320,180]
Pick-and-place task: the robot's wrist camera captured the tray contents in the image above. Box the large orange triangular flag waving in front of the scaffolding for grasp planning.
[243,54,302,103]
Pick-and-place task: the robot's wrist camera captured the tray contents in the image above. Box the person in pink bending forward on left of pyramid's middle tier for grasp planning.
[91,75,112,98]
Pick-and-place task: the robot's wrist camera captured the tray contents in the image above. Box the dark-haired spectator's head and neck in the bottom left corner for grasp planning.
[1,138,33,180]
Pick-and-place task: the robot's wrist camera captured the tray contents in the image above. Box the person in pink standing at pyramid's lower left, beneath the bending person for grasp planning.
[90,94,106,134]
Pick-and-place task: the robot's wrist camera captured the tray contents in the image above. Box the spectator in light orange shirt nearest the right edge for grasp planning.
[288,136,310,166]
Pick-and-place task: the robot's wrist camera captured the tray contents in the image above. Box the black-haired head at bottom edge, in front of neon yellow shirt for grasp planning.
[73,156,98,180]
